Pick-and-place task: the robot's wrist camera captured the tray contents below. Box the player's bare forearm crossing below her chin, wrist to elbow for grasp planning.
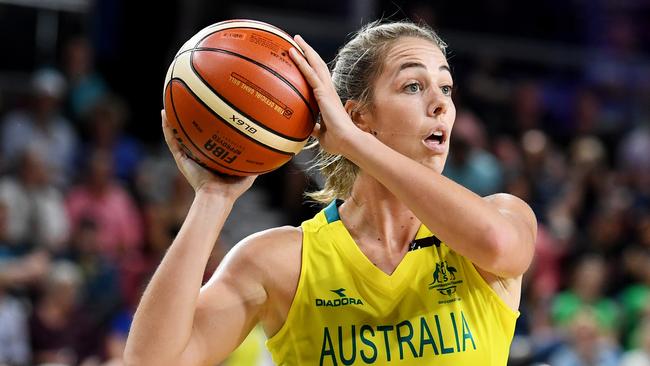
[345,133,514,269]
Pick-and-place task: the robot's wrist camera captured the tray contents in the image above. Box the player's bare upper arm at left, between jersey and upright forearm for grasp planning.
[181,242,267,365]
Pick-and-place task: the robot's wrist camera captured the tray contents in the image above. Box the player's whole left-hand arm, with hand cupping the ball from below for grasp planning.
[124,115,266,366]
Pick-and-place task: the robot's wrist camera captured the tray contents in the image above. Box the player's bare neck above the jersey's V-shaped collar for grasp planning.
[339,172,421,252]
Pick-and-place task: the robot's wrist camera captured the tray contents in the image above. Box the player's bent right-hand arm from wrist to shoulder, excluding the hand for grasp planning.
[334,134,537,278]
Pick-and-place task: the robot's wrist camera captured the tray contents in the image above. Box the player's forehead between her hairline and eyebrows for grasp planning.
[382,37,449,75]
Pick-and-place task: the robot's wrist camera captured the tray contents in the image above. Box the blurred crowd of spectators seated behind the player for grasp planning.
[0,0,650,366]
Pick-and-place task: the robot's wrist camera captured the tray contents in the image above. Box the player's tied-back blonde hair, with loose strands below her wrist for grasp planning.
[306,20,447,203]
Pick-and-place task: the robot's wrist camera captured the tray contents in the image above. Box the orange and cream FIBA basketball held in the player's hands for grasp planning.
[163,20,318,176]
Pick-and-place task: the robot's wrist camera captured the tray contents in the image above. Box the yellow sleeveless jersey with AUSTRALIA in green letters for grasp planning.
[266,201,519,366]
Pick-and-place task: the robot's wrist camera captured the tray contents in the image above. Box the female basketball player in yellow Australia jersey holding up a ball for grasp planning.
[126,23,536,365]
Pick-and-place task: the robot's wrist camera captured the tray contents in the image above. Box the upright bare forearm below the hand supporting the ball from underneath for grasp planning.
[125,192,233,365]
